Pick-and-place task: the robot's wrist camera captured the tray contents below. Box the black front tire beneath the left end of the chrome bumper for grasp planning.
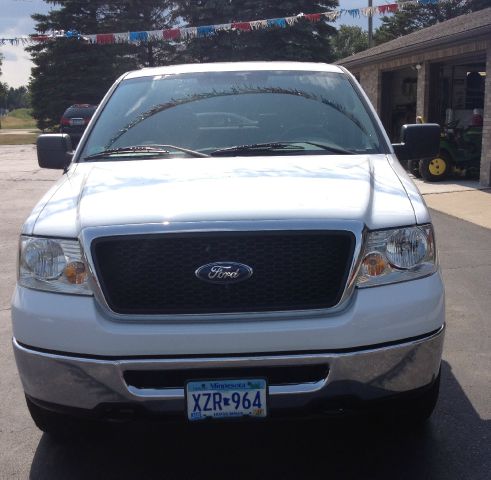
[26,396,96,440]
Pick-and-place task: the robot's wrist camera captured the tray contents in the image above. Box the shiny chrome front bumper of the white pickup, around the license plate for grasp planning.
[13,327,444,414]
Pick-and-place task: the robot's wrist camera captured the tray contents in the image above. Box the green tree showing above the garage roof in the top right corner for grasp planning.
[374,0,490,44]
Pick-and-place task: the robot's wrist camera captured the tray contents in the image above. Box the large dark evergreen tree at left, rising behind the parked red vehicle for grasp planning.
[28,0,176,130]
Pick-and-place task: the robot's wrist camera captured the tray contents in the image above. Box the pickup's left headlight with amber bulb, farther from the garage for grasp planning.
[18,236,92,295]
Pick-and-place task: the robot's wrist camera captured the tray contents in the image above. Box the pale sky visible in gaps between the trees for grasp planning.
[0,0,380,87]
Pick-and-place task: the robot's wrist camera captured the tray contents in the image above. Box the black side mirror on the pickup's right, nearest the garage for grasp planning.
[392,123,440,162]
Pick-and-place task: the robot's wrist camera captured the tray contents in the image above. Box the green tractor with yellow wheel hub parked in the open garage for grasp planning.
[407,120,482,182]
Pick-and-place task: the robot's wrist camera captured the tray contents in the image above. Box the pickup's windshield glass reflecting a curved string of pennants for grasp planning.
[80,71,383,161]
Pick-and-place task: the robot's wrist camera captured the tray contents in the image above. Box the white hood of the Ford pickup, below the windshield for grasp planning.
[24,155,416,238]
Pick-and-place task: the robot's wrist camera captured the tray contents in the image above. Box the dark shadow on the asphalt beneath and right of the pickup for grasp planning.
[30,362,491,480]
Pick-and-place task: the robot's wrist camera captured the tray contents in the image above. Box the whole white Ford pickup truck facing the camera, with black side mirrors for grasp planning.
[12,62,444,432]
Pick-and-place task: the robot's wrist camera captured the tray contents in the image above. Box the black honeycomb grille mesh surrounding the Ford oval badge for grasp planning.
[91,230,355,315]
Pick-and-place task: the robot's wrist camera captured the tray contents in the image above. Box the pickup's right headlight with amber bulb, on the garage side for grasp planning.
[357,225,437,287]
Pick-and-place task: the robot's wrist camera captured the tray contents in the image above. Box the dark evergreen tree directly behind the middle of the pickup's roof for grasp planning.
[168,0,338,62]
